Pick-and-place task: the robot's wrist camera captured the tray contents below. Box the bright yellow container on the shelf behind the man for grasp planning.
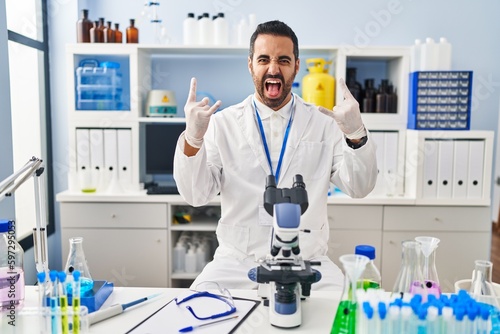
[302,58,335,110]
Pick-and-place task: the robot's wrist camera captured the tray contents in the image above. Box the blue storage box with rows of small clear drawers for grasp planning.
[408,71,472,130]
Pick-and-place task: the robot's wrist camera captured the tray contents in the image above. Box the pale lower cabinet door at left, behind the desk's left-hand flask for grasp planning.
[62,228,168,287]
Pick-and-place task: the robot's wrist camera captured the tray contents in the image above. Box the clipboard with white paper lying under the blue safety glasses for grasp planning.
[126,291,261,334]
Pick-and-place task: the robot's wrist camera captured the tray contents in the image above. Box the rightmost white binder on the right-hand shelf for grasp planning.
[467,140,484,198]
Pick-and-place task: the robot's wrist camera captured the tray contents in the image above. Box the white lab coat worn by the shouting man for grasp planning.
[174,95,377,288]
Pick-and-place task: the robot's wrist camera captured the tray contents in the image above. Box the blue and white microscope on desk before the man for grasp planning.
[248,174,321,328]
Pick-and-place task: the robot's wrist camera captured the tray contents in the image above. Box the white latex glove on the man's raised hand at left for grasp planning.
[184,78,221,148]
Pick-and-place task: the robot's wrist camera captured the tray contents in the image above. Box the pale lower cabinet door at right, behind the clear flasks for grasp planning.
[381,231,491,292]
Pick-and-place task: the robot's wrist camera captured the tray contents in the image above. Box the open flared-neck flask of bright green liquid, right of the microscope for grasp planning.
[331,254,370,334]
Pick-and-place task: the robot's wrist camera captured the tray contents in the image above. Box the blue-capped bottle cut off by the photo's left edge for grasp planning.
[0,219,24,310]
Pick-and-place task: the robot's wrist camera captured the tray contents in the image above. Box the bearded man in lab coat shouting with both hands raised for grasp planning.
[174,21,377,289]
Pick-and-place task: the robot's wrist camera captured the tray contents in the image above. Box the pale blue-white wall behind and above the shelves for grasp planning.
[44,0,500,280]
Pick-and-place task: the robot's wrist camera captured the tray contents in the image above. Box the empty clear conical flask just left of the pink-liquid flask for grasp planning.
[392,240,427,300]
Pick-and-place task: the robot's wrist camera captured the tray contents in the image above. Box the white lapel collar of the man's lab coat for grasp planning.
[237,95,313,185]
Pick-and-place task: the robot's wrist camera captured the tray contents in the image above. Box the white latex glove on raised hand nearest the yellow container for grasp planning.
[318,78,366,139]
